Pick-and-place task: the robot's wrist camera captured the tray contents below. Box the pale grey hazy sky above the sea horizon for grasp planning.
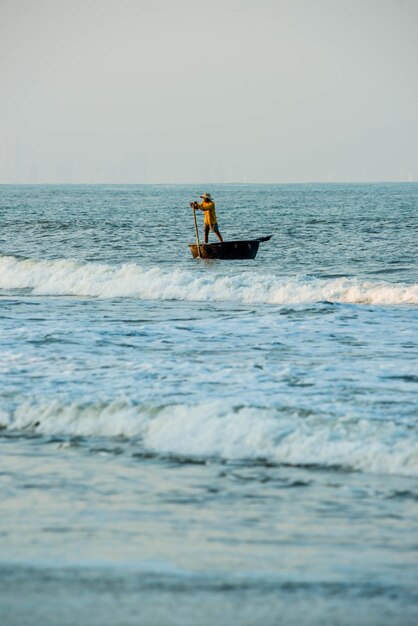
[0,0,418,184]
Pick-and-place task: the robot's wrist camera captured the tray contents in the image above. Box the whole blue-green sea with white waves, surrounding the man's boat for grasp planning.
[0,183,418,626]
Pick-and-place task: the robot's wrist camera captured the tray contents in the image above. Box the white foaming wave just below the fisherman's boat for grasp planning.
[0,256,418,305]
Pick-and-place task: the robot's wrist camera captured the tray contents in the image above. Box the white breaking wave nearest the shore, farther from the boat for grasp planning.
[0,400,418,476]
